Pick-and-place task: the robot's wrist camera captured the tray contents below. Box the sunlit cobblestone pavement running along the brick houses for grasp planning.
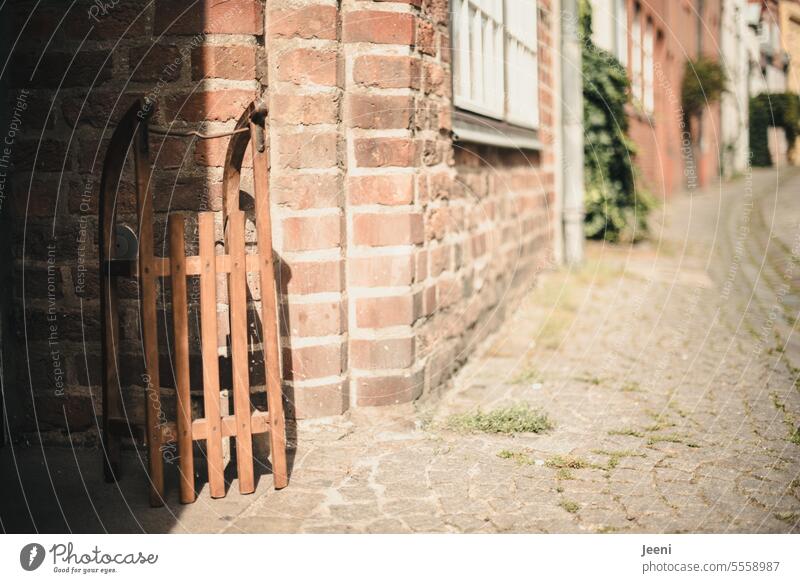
[3,171,800,533]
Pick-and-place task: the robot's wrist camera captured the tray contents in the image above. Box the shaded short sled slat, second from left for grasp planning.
[168,215,195,504]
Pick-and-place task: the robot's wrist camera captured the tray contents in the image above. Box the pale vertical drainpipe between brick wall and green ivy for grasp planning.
[560,0,584,265]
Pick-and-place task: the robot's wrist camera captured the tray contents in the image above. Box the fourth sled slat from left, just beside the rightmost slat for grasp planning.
[226,210,255,494]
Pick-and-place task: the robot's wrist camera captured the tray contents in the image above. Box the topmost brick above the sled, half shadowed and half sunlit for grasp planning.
[153,0,264,34]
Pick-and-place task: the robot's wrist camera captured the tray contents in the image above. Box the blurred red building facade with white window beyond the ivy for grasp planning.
[591,0,722,196]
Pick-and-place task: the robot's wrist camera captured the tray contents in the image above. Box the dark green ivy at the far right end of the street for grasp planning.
[750,92,800,166]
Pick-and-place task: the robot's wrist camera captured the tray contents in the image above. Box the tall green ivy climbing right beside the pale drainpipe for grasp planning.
[580,0,655,242]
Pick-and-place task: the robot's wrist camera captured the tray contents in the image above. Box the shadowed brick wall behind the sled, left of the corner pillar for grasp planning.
[3,0,263,440]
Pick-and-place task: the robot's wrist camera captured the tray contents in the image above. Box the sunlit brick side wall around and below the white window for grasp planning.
[418,1,560,390]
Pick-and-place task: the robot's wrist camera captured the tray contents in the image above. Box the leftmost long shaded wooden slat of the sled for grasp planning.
[134,118,164,506]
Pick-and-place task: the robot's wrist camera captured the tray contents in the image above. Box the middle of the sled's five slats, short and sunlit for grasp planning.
[198,213,225,498]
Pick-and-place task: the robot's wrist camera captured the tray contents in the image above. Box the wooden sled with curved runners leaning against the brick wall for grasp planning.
[98,100,288,506]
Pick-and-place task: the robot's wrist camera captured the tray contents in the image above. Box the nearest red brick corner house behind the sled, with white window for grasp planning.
[3,0,560,440]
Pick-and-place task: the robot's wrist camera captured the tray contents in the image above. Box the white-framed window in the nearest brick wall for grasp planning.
[452,0,539,128]
